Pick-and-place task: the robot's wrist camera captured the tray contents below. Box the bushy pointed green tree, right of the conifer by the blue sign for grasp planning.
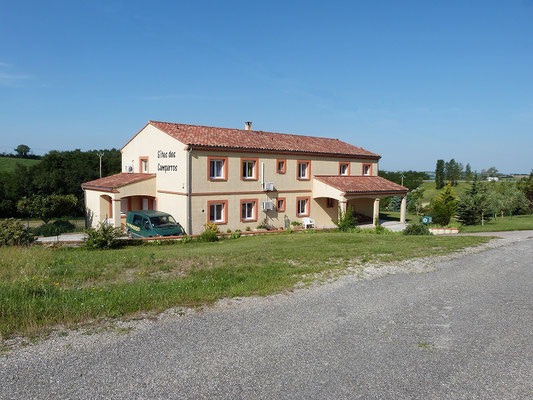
[457,177,491,225]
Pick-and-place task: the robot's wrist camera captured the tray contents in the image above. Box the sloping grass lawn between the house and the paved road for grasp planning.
[0,232,488,337]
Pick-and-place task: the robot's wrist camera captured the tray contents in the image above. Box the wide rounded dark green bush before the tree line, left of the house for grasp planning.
[17,194,78,224]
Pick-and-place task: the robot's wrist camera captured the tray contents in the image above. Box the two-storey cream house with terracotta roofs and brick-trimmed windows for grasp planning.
[82,121,408,234]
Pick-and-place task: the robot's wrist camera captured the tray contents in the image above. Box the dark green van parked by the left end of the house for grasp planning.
[126,210,185,238]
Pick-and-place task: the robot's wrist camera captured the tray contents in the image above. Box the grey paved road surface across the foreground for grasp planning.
[0,233,533,399]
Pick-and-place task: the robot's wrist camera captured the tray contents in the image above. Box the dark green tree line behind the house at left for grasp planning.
[0,149,121,218]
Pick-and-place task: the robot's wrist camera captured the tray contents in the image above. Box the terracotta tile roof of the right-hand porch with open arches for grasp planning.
[315,175,409,194]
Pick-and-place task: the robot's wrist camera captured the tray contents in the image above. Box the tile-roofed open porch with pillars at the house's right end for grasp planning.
[313,175,409,225]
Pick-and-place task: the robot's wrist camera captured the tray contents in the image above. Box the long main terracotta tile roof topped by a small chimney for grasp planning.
[143,121,380,159]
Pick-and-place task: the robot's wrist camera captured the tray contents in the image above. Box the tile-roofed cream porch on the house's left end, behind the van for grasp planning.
[81,173,157,227]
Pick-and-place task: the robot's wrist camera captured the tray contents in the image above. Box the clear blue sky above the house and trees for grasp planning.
[0,0,533,173]
